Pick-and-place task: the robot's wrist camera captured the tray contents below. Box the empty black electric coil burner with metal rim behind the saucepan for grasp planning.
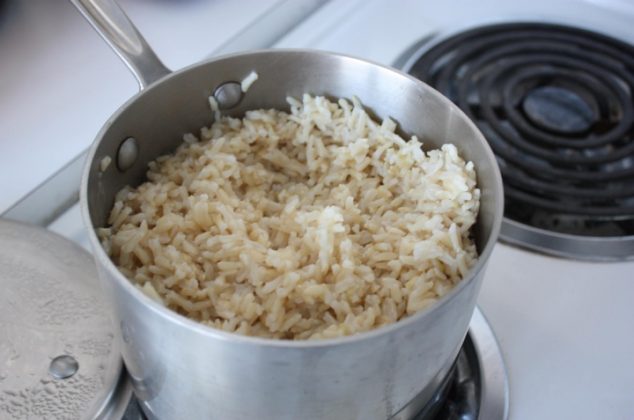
[405,23,634,260]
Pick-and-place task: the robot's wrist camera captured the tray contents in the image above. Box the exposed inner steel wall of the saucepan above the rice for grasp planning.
[82,50,502,253]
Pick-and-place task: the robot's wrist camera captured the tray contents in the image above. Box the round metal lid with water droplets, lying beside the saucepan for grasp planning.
[0,220,132,419]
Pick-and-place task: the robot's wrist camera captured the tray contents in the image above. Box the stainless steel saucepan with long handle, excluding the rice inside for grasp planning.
[72,0,503,420]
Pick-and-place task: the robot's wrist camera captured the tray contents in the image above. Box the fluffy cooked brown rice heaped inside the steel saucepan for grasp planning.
[99,95,480,339]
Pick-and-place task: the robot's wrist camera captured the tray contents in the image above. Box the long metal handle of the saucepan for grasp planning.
[70,0,170,90]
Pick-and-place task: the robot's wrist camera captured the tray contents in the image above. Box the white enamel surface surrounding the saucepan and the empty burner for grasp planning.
[0,0,634,420]
